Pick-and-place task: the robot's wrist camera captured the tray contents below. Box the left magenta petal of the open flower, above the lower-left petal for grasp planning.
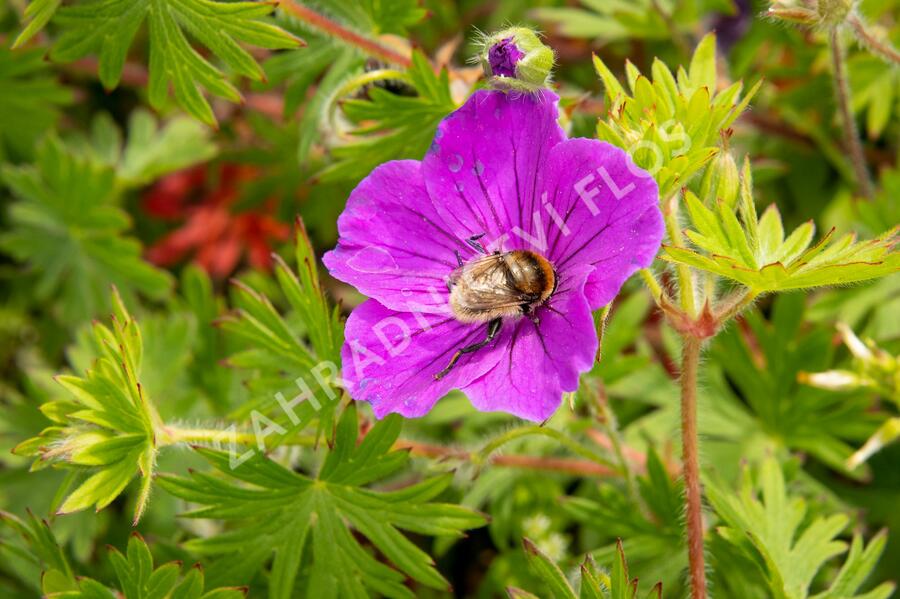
[323,160,469,313]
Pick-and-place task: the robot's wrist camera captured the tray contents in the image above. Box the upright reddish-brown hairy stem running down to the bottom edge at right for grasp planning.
[681,335,706,599]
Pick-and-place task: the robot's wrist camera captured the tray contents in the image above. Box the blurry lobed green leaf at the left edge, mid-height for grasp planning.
[0,137,172,323]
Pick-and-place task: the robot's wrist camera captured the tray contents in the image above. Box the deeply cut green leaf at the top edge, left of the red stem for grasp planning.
[51,0,301,125]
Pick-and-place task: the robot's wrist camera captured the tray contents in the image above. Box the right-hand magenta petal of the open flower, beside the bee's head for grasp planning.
[542,139,664,309]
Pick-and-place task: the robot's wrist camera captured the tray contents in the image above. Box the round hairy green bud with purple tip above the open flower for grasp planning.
[479,27,554,91]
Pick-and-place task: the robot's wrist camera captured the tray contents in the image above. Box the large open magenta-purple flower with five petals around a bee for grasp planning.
[324,90,663,421]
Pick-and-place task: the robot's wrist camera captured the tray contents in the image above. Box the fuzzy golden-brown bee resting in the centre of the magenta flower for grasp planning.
[434,233,559,380]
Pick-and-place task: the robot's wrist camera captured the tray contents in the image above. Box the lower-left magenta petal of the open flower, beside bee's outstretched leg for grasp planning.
[341,300,500,418]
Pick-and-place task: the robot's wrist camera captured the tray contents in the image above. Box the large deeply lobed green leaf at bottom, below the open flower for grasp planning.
[160,406,484,598]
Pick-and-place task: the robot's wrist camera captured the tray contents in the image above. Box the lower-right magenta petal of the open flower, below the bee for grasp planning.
[463,267,598,422]
